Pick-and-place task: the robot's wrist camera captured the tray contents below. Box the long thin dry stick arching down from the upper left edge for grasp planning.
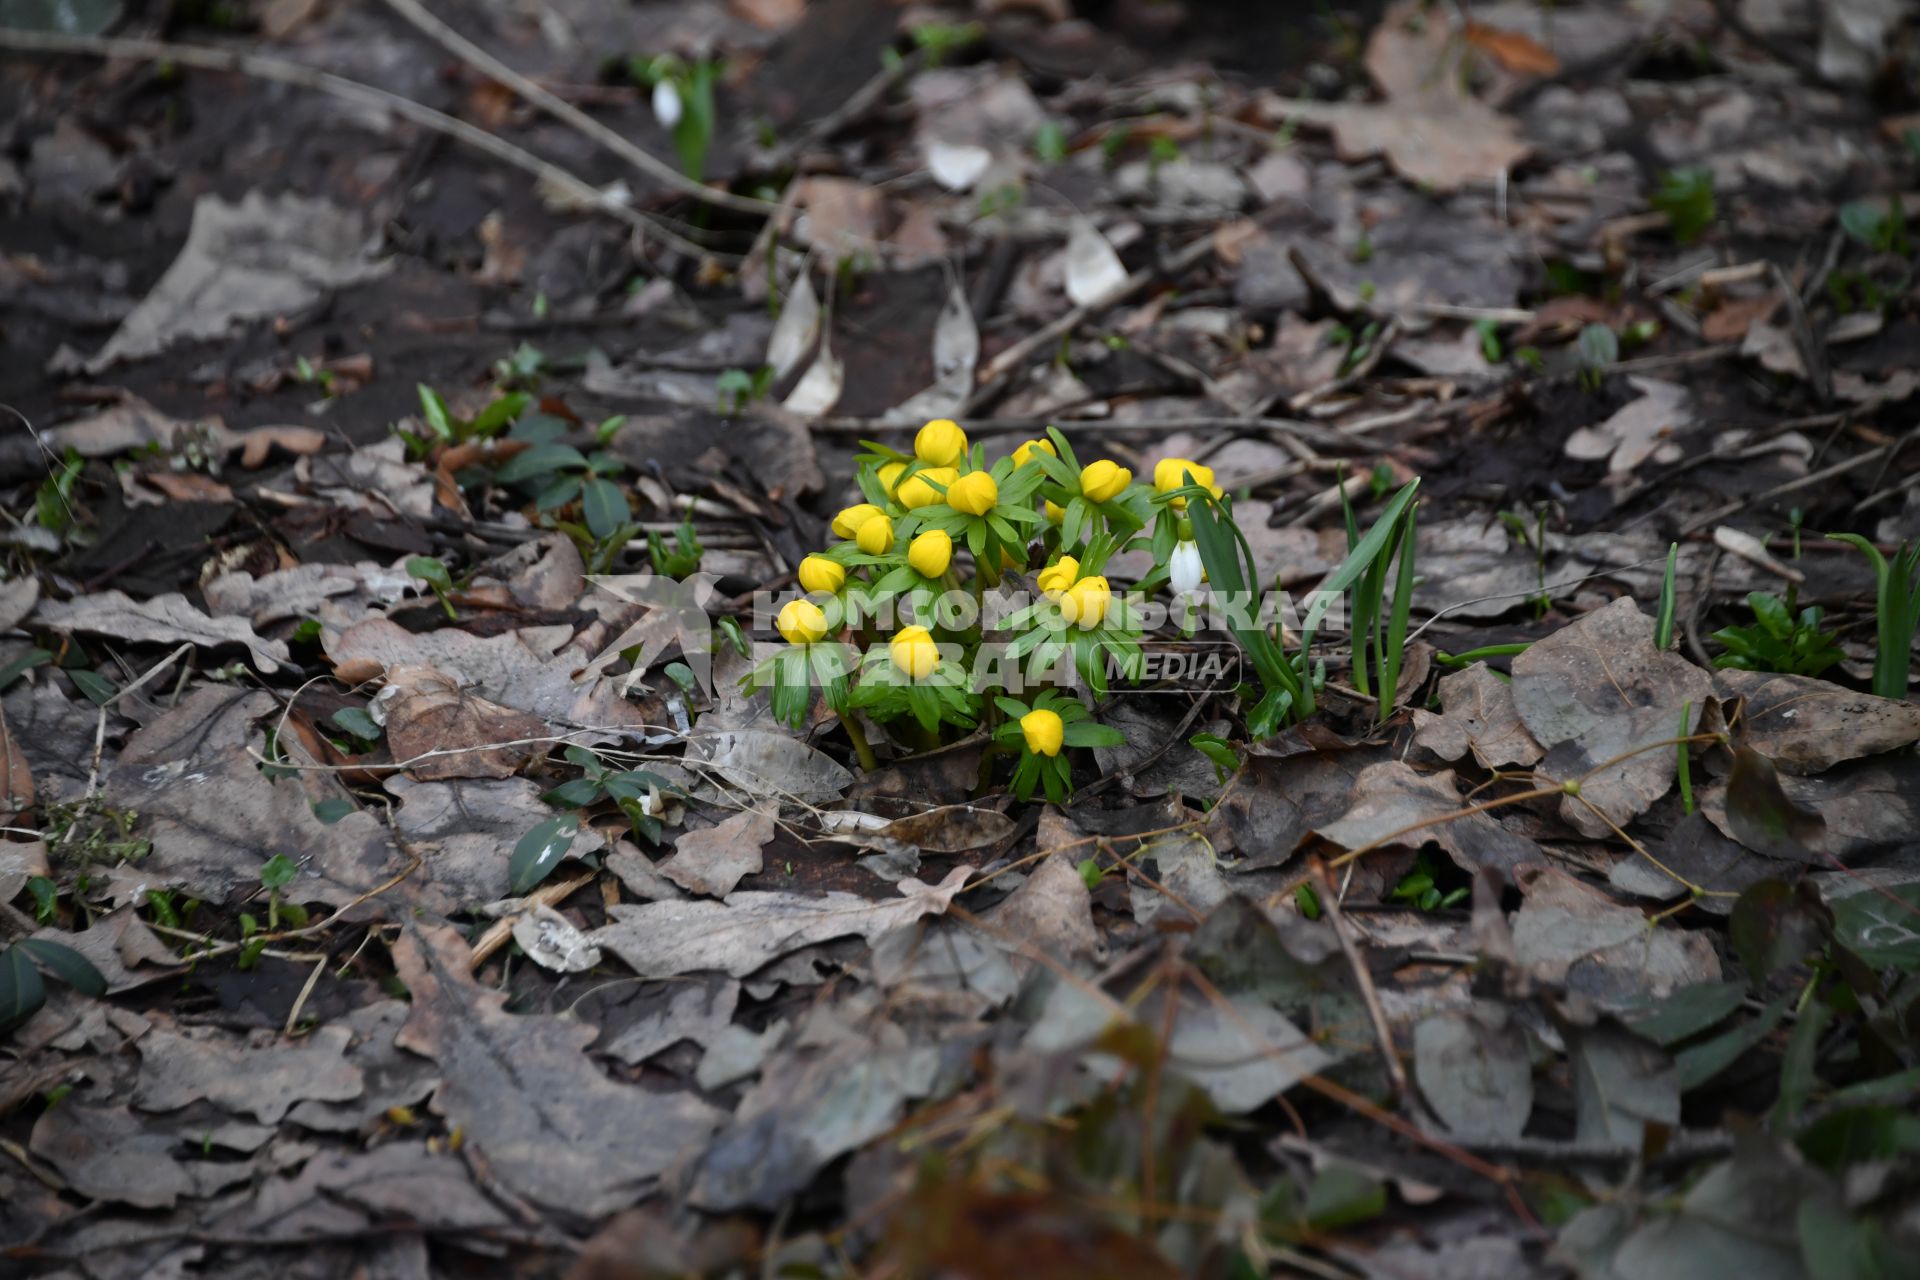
[0,29,708,257]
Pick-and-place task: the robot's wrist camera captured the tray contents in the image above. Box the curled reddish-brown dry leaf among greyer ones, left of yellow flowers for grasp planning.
[380,666,551,781]
